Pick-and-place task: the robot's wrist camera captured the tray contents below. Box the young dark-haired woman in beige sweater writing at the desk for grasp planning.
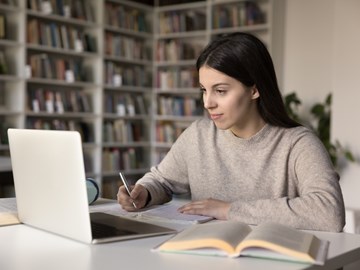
[118,33,345,231]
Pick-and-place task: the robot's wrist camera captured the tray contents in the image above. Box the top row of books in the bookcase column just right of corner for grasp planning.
[159,10,206,34]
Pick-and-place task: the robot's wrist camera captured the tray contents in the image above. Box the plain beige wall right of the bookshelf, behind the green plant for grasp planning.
[280,0,360,209]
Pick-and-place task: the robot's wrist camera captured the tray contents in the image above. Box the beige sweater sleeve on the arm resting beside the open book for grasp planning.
[229,131,345,232]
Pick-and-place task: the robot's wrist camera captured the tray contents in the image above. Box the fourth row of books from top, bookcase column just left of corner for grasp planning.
[104,92,148,116]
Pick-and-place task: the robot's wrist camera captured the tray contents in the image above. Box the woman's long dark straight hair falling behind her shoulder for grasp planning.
[196,33,300,128]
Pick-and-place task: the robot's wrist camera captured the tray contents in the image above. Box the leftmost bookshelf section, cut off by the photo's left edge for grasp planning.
[0,0,25,196]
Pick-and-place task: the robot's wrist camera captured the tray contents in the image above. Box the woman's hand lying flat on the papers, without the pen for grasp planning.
[178,199,230,220]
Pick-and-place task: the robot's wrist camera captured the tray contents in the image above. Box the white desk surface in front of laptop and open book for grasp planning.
[0,199,360,270]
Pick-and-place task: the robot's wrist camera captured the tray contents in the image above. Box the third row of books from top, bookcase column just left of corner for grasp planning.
[104,61,151,87]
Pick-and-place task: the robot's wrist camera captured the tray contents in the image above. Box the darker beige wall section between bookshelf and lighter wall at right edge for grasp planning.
[280,0,334,109]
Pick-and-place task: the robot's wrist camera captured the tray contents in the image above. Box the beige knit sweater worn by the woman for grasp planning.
[138,119,345,231]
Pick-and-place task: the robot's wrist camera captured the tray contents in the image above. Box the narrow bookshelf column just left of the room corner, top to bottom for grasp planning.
[102,0,153,197]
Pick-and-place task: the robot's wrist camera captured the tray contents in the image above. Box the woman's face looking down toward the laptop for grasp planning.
[199,66,261,135]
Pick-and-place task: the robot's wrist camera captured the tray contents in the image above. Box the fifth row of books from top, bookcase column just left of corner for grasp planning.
[103,119,146,143]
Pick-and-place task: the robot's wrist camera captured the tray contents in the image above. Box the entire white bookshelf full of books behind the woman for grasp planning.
[0,0,274,198]
